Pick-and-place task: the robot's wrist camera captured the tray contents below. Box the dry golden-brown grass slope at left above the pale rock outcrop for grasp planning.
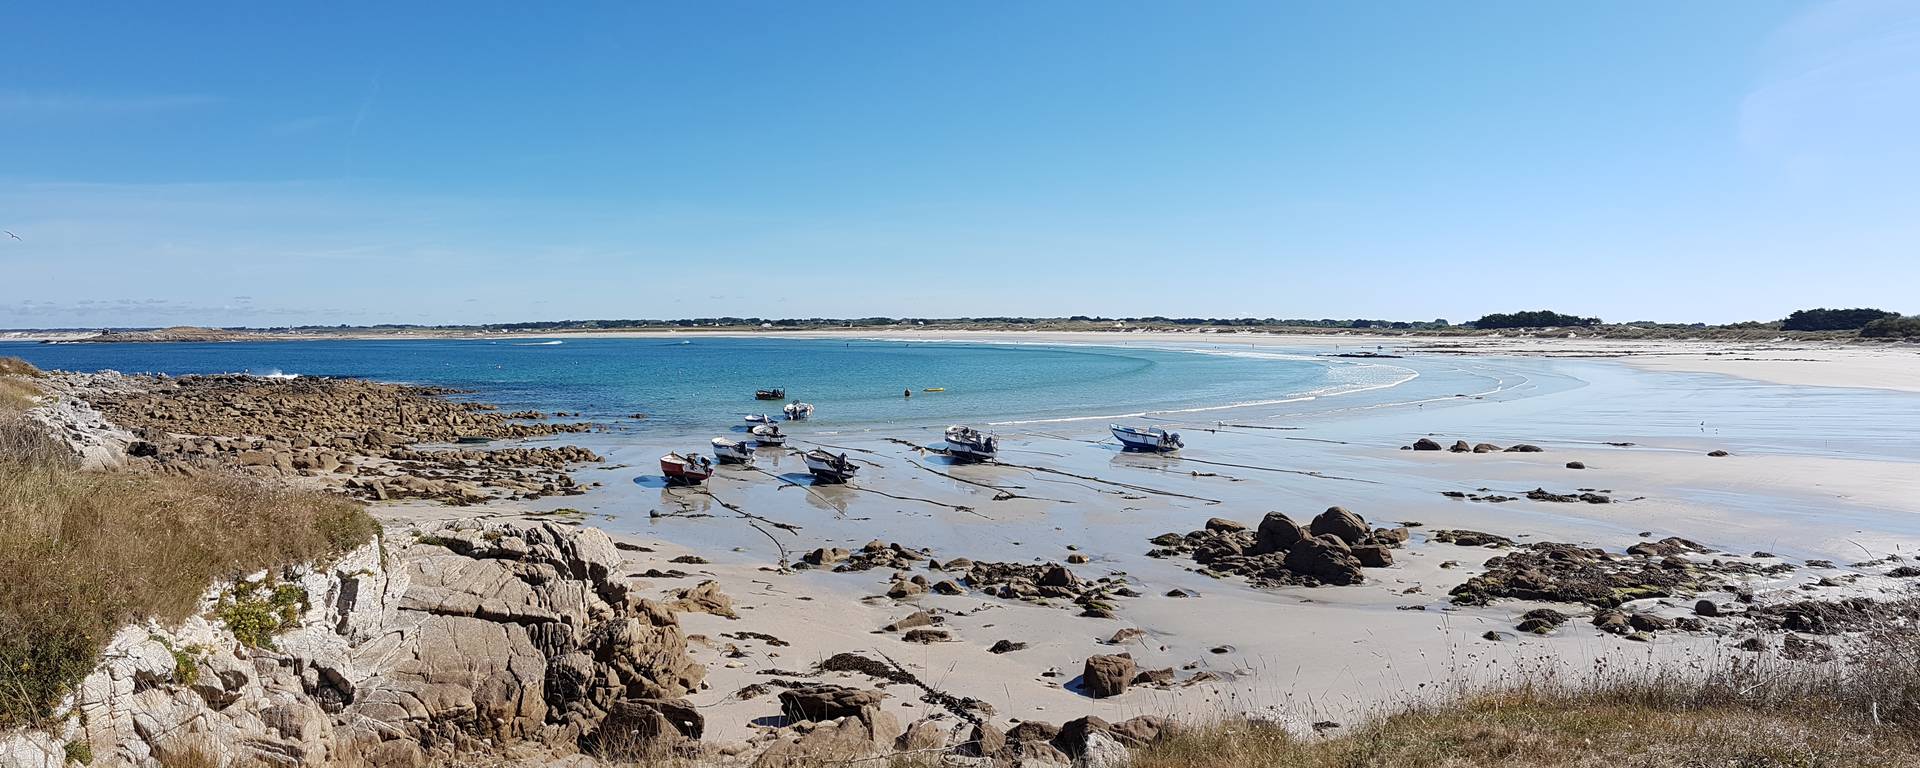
[0,417,378,730]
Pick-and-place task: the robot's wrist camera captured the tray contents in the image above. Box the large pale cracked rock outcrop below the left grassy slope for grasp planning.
[0,524,705,766]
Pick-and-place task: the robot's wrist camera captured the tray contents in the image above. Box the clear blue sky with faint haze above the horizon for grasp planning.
[0,0,1920,326]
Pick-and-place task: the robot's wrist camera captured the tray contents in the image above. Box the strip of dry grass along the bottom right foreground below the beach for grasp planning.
[1129,603,1920,768]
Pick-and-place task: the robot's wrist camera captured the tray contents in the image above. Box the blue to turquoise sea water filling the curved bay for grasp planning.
[0,338,1413,430]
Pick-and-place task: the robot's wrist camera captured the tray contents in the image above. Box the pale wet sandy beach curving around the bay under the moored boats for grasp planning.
[311,334,1920,737]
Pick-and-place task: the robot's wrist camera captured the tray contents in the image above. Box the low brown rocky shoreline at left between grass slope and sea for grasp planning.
[42,372,601,505]
